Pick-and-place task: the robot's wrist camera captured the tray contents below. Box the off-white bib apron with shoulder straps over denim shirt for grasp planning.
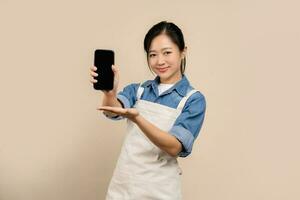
[106,83,197,200]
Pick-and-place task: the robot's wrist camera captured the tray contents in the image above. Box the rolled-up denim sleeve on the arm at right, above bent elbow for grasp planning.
[169,92,206,157]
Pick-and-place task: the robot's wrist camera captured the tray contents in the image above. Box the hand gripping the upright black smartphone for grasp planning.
[90,65,119,96]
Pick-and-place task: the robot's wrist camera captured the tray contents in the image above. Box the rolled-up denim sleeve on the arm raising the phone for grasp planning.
[103,83,139,120]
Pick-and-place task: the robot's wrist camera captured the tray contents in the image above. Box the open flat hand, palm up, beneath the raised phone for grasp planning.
[97,106,139,121]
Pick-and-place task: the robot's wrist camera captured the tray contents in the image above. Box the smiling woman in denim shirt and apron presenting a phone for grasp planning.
[91,21,206,200]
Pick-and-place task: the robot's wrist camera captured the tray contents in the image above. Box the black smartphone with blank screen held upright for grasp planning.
[94,49,115,91]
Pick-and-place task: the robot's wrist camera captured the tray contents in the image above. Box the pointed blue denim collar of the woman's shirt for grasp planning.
[143,74,190,96]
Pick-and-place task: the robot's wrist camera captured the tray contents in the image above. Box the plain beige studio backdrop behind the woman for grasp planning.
[0,0,300,200]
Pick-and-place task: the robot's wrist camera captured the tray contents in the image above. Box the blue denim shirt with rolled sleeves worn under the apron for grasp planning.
[105,75,206,157]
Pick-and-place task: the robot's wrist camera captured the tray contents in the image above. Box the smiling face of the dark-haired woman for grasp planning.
[148,34,186,83]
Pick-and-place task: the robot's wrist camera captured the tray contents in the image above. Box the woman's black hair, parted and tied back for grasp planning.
[144,21,186,74]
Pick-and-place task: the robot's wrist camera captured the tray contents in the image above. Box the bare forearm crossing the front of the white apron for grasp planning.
[133,115,182,157]
